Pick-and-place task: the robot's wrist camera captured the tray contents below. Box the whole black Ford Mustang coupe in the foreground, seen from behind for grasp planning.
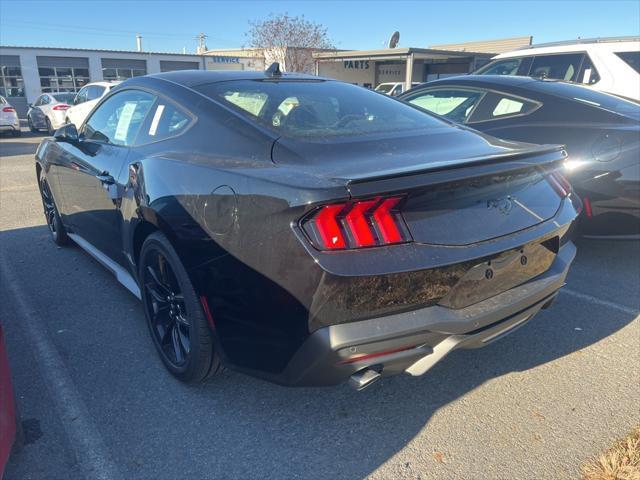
[36,69,576,388]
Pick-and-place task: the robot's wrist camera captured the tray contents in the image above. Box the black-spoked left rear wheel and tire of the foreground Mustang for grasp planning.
[138,232,220,383]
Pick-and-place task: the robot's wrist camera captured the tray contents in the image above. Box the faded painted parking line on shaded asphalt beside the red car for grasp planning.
[0,255,124,480]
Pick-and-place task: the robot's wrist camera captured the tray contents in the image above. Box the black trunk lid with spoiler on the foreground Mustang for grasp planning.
[273,126,566,246]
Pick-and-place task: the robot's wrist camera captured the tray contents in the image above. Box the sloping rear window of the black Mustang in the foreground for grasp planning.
[197,80,442,137]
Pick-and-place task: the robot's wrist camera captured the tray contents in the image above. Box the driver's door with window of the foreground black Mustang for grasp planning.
[58,89,156,265]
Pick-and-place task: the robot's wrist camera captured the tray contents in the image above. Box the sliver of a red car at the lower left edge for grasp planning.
[0,321,22,478]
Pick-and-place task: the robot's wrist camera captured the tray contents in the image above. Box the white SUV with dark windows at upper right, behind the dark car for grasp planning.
[474,37,640,100]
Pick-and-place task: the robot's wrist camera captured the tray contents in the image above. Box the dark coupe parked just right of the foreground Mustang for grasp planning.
[400,75,640,237]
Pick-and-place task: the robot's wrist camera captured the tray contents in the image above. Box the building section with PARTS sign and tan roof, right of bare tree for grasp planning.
[313,36,533,88]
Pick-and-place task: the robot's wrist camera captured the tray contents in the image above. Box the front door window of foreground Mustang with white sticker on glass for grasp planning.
[83,90,156,146]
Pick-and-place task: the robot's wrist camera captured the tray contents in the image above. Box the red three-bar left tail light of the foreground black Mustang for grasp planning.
[302,197,411,250]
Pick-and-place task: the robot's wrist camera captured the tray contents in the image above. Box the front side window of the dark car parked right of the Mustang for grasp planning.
[405,89,483,123]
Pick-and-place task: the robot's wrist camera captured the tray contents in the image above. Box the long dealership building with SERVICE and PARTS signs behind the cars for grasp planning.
[0,36,532,117]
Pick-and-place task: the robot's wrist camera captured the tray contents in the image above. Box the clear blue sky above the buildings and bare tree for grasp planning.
[0,0,640,52]
